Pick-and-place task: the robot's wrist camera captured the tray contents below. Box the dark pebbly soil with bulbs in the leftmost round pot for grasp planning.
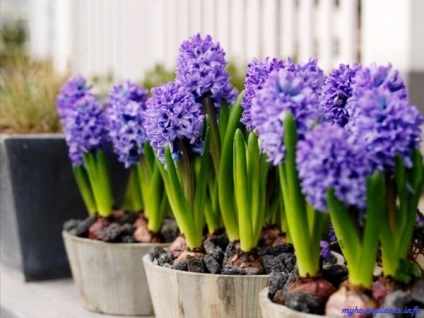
[63,214,178,243]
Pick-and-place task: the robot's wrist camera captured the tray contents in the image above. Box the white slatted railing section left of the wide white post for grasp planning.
[40,0,359,80]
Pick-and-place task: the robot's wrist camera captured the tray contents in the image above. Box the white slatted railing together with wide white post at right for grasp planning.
[29,0,424,80]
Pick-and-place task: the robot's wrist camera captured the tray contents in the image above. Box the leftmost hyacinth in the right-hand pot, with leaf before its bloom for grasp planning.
[251,64,335,308]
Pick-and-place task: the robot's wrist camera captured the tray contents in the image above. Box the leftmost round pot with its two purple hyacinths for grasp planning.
[58,77,173,315]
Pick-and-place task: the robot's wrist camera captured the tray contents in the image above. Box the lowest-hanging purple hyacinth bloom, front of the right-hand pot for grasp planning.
[296,125,373,212]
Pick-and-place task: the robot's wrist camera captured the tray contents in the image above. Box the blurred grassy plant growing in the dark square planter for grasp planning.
[0,58,68,133]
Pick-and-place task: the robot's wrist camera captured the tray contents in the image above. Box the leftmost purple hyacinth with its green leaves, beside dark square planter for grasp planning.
[58,77,114,217]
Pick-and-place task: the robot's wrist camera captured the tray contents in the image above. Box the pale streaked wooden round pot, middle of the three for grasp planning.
[143,255,269,318]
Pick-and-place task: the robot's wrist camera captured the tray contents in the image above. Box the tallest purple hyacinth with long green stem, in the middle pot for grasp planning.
[176,34,241,241]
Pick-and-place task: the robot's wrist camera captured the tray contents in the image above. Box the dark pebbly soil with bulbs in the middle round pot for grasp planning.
[150,229,296,275]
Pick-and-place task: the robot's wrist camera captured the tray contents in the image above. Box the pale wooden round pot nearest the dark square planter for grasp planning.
[62,231,169,316]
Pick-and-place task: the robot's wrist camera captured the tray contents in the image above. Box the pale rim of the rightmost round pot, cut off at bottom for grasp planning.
[259,288,323,318]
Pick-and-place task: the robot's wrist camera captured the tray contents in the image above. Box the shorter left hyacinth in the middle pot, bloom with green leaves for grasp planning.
[145,82,210,250]
